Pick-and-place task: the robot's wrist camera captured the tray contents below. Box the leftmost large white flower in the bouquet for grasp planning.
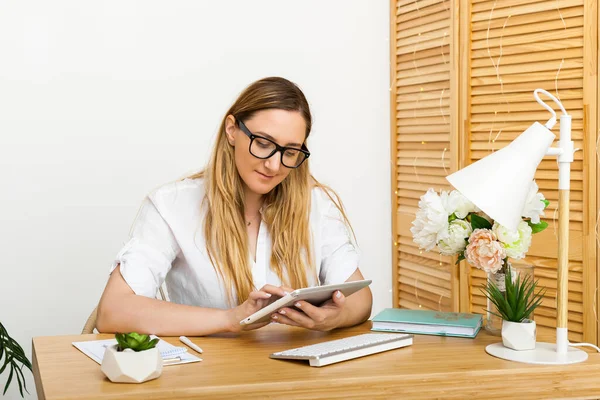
[410,189,448,251]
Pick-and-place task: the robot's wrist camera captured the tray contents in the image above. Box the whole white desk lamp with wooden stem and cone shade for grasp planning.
[446,89,587,364]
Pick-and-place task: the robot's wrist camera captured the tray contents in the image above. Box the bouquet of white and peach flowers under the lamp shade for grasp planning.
[410,181,549,274]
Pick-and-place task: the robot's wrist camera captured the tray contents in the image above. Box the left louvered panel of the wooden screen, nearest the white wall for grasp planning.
[390,0,459,311]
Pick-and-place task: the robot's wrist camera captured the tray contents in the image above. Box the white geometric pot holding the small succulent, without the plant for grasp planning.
[100,345,163,383]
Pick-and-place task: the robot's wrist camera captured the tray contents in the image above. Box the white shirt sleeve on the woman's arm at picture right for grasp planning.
[319,200,360,285]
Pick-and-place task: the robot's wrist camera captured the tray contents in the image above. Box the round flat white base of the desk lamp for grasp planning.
[485,342,587,365]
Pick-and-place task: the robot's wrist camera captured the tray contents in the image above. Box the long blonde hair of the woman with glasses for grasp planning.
[189,77,349,304]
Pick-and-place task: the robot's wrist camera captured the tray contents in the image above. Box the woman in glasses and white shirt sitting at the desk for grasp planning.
[96,78,372,336]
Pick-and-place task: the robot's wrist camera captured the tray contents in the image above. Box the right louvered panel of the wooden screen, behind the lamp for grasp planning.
[465,0,596,341]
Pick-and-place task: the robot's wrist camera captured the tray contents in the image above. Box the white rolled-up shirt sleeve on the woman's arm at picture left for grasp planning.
[110,197,180,298]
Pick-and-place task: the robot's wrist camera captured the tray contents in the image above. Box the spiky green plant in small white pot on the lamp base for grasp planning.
[481,268,546,350]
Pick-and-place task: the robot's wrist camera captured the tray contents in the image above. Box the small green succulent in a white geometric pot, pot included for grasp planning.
[101,332,163,383]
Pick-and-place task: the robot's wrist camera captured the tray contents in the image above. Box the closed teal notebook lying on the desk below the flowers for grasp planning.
[371,308,482,338]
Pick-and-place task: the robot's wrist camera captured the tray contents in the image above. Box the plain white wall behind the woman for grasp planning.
[0,0,392,398]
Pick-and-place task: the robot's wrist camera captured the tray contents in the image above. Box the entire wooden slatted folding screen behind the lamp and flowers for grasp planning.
[390,0,600,343]
